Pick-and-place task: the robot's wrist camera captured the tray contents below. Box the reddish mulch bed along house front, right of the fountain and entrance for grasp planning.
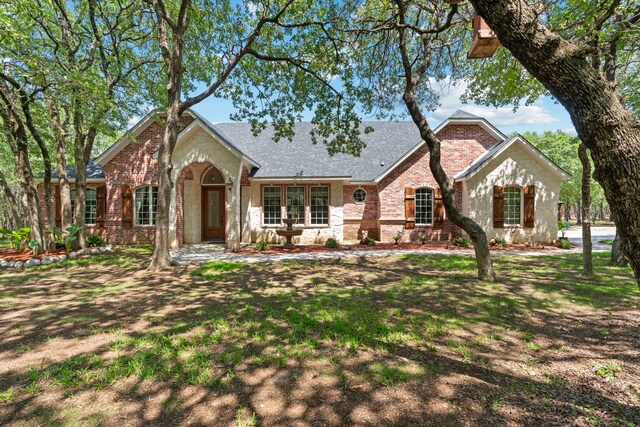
[236,242,558,255]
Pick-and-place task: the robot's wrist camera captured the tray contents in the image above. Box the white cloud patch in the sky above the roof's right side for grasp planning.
[429,79,559,126]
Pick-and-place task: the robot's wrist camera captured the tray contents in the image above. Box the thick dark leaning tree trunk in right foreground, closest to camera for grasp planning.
[472,0,640,286]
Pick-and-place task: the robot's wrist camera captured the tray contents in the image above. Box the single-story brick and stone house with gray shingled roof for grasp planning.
[41,111,568,247]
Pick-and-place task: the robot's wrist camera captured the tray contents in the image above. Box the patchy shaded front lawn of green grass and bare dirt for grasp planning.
[0,248,640,426]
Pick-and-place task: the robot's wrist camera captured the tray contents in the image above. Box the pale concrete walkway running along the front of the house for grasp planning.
[171,227,615,263]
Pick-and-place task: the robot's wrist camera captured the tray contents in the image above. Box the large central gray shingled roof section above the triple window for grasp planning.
[213,122,421,181]
